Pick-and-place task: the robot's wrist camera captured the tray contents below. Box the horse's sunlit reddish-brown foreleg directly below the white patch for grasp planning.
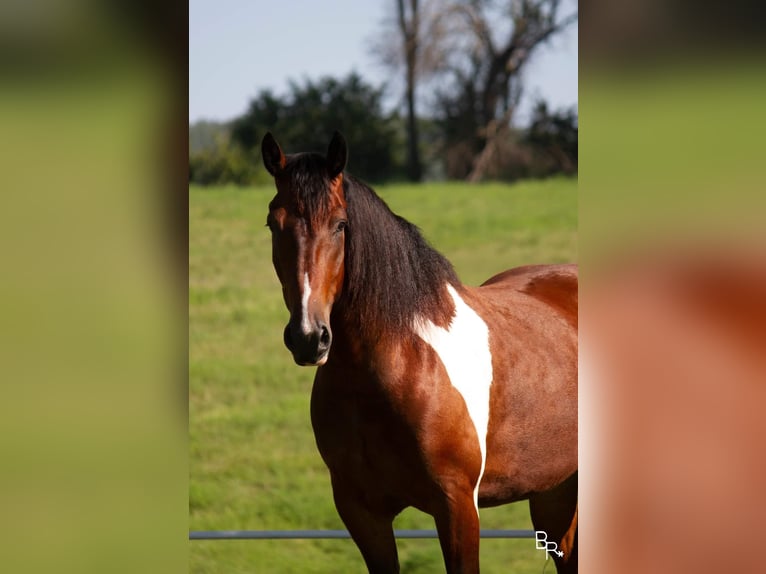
[434,489,479,574]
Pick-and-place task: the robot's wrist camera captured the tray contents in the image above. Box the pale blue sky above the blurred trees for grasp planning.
[189,0,577,124]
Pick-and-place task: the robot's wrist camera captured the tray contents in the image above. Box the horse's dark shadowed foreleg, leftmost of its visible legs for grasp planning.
[332,479,399,574]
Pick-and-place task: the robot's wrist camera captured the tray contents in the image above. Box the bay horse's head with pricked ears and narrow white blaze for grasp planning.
[261,132,348,365]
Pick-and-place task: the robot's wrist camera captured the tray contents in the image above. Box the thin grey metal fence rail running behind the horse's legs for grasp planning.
[189,529,535,540]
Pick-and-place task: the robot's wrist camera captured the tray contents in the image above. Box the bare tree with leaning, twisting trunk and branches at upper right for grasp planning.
[426,0,577,181]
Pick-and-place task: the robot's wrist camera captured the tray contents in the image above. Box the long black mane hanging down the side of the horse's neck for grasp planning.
[341,175,460,336]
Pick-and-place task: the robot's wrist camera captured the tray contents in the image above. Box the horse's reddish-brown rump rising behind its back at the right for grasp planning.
[480,264,578,328]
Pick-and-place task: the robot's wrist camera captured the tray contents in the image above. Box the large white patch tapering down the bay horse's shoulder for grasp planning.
[415,284,492,513]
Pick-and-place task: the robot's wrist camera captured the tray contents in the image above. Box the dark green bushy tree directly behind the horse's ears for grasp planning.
[231,73,395,181]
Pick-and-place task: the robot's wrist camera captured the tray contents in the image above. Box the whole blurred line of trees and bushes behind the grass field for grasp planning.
[189,0,578,185]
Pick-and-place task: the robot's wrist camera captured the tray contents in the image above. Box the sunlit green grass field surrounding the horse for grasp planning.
[189,179,577,574]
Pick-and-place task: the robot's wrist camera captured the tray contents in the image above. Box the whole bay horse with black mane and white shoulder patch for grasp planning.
[261,132,577,573]
